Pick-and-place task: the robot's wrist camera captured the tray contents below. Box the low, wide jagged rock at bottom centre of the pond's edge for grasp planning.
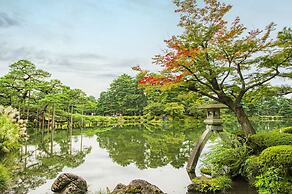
[110,179,165,194]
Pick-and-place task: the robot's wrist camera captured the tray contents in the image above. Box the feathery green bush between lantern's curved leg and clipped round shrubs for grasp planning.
[203,132,249,176]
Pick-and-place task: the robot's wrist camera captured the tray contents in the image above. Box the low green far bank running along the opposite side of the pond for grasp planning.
[31,113,292,131]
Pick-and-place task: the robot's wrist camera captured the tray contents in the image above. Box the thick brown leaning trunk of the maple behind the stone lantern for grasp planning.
[234,106,256,136]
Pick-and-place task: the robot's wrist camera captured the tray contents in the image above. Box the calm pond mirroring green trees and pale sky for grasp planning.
[2,122,292,194]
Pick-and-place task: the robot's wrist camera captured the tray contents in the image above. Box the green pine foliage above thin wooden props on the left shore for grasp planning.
[0,60,96,127]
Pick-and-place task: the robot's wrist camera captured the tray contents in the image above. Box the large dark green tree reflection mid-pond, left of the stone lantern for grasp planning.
[97,124,203,169]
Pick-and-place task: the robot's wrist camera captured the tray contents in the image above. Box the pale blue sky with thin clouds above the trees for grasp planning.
[0,0,292,97]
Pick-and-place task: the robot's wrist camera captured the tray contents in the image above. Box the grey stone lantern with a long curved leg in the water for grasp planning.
[187,104,227,179]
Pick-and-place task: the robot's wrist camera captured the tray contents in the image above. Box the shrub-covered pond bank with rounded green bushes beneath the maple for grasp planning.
[193,126,292,194]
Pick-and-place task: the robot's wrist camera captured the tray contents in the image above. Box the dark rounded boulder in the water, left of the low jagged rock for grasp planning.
[51,173,87,194]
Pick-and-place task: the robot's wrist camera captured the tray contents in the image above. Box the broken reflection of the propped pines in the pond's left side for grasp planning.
[2,131,91,193]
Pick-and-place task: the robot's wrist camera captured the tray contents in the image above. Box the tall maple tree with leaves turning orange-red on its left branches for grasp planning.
[139,0,292,135]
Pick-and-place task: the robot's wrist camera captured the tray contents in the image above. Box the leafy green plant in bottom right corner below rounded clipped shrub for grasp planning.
[255,167,292,194]
